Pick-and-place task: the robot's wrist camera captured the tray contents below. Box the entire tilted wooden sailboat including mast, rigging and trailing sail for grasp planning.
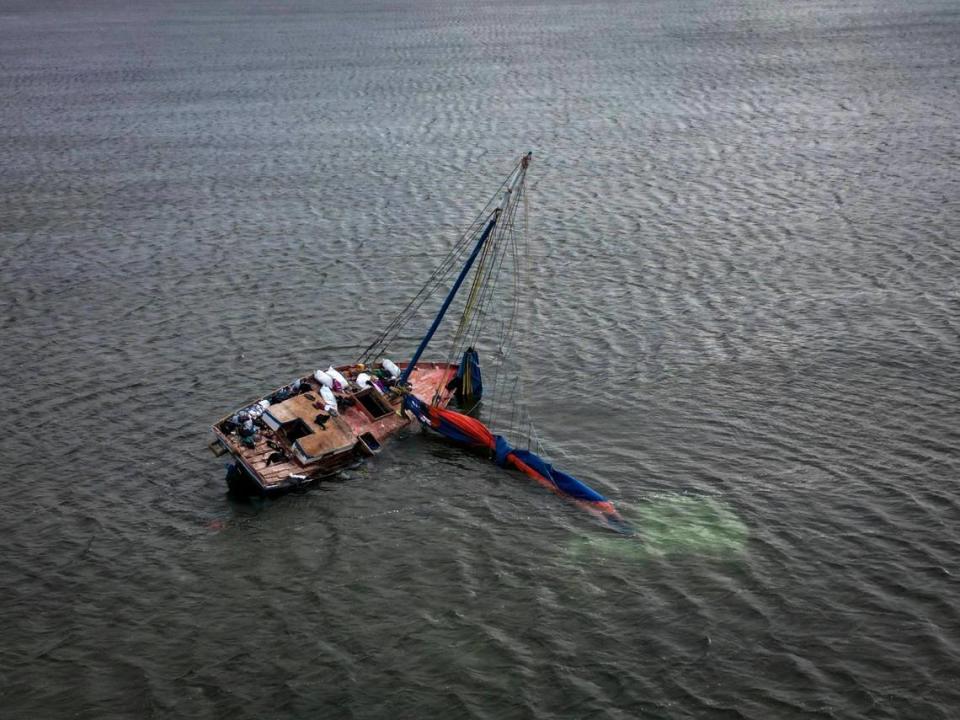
[211,153,633,534]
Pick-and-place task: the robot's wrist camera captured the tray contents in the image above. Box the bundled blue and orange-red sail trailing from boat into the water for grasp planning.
[403,395,630,532]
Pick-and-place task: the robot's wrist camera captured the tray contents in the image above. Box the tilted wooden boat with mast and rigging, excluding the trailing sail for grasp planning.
[210,153,531,493]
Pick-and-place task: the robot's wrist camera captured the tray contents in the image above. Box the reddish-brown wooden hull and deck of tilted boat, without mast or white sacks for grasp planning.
[211,362,457,494]
